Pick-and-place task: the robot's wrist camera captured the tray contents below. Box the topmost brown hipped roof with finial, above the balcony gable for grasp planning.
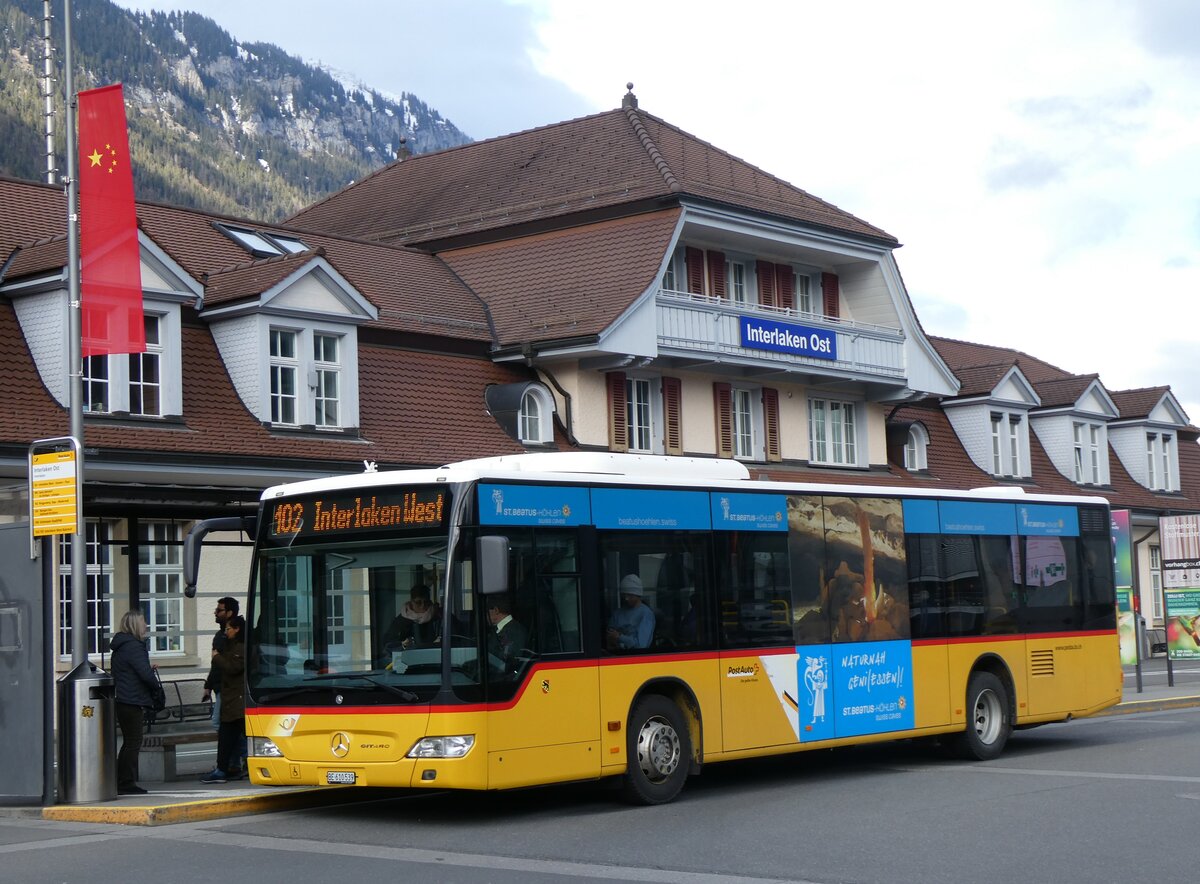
[292,109,896,245]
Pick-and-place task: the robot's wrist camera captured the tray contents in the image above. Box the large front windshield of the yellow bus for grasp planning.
[247,534,476,704]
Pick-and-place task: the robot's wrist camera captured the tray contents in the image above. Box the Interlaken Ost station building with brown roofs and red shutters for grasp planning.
[0,88,1200,675]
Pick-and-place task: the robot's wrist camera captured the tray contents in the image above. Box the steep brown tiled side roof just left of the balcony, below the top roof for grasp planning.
[440,209,679,347]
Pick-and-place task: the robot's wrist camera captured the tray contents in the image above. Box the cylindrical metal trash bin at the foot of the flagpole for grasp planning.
[59,662,116,804]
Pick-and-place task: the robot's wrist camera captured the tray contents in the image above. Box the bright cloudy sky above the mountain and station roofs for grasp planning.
[112,0,1200,425]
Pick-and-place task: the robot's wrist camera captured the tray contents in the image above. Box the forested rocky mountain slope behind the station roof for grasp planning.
[0,0,470,221]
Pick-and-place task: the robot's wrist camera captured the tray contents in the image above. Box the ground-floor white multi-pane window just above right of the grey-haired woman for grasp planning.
[138,522,184,655]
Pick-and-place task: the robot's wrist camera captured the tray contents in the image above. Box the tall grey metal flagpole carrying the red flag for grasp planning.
[62,0,88,667]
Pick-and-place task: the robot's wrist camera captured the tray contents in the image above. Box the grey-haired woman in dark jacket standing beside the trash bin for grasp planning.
[108,611,158,795]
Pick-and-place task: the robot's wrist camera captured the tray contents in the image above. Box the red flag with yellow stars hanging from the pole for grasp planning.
[79,83,146,356]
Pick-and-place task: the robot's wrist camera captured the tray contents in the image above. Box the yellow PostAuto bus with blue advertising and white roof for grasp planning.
[187,452,1122,804]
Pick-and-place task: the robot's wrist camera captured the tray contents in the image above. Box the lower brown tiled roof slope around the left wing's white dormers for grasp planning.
[0,301,540,471]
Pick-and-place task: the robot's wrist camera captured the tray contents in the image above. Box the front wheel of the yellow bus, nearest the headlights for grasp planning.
[624,694,691,805]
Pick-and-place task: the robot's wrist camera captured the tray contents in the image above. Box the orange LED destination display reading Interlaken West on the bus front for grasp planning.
[268,488,448,540]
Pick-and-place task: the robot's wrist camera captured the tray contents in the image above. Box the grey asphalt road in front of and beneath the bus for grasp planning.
[0,708,1200,884]
